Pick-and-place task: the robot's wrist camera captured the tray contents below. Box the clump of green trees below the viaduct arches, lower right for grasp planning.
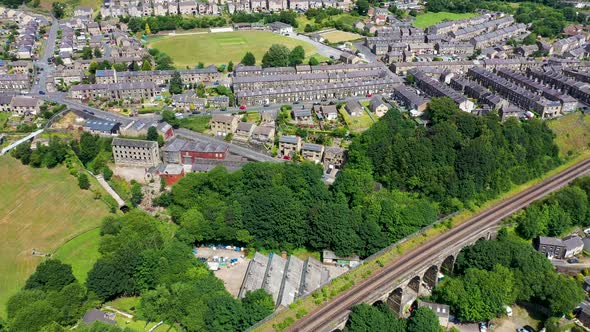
[433,235,585,321]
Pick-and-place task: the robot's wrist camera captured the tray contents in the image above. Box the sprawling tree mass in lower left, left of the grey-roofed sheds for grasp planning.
[7,210,274,332]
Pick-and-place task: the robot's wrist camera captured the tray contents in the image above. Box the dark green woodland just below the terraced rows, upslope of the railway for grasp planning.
[346,98,560,212]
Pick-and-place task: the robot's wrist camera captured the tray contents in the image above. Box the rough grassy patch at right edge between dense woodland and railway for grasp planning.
[547,112,590,158]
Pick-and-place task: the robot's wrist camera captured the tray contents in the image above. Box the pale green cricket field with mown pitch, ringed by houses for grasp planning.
[148,31,316,68]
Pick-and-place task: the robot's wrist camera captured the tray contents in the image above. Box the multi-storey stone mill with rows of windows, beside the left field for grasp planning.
[111,138,160,167]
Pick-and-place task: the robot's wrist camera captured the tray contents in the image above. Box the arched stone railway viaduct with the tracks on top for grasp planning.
[287,159,590,332]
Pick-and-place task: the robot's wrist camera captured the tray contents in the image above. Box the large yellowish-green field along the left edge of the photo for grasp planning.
[0,156,108,318]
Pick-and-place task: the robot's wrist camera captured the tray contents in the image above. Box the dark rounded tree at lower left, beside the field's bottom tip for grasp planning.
[25,259,76,291]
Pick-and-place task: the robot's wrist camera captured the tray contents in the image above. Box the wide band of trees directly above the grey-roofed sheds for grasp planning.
[159,163,437,256]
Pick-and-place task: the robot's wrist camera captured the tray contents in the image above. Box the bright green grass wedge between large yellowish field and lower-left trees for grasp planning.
[53,228,100,282]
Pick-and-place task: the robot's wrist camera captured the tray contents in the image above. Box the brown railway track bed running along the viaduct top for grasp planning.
[287,159,590,332]
